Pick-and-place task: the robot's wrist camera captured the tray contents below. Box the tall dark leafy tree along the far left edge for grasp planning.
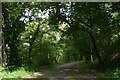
[2,3,24,67]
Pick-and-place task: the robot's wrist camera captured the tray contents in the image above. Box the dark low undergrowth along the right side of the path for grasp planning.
[72,62,120,80]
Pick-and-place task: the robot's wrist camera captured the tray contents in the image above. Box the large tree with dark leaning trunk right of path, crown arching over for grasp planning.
[47,2,118,63]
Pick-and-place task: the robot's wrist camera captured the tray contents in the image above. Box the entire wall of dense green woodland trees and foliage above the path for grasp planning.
[2,2,120,75]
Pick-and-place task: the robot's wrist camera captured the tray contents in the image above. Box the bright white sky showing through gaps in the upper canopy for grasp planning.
[20,1,71,23]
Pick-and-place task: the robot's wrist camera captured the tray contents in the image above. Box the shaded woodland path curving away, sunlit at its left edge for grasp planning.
[22,61,99,80]
